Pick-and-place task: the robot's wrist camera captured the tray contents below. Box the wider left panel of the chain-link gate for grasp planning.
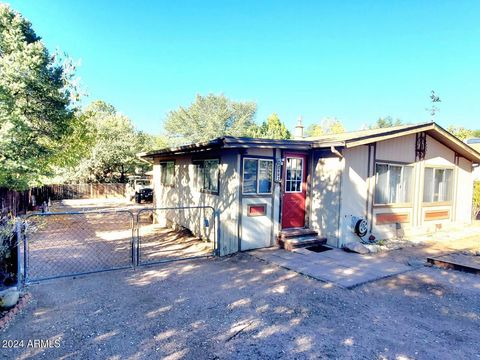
[24,211,134,282]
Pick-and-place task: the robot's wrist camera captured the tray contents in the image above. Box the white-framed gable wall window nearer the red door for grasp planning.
[375,164,413,204]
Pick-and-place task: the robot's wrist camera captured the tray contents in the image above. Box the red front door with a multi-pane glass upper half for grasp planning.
[282,153,307,229]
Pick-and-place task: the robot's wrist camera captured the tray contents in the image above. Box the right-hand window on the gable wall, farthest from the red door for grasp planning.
[423,168,453,202]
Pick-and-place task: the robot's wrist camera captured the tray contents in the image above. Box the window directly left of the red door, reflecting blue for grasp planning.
[243,159,273,194]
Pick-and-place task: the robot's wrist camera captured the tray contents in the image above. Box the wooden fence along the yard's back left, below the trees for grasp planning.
[0,184,126,217]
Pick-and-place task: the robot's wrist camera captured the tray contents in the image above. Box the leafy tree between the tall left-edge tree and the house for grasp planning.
[62,101,155,182]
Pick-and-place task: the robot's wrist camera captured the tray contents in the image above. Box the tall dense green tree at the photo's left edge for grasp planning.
[0,4,78,189]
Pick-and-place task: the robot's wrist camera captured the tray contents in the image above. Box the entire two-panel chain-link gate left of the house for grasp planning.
[19,206,218,284]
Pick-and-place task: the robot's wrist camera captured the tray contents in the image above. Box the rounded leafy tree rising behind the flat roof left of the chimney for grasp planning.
[165,94,257,144]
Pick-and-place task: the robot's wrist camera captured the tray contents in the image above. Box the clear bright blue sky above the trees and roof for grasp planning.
[8,0,480,133]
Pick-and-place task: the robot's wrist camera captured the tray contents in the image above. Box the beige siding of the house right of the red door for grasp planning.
[326,135,473,245]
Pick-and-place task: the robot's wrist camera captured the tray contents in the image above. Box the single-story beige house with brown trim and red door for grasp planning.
[142,123,480,255]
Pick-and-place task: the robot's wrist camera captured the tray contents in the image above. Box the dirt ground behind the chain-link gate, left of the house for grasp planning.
[23,199,213,281]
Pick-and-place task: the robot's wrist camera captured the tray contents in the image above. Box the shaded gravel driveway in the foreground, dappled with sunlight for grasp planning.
[0,254,480,359]
